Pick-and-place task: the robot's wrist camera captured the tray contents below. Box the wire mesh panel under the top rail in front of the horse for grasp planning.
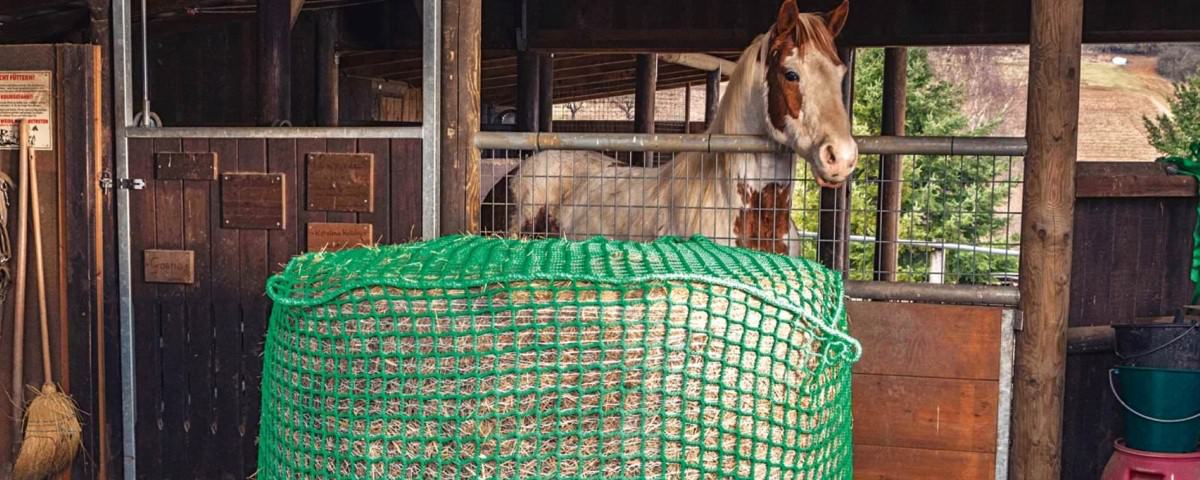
[481,150,1021,284]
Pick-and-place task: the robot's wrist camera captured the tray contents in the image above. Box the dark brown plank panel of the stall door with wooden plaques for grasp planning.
[130,138,421,480]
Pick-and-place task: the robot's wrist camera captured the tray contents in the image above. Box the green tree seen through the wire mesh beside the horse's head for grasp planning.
[796,48,1016,283]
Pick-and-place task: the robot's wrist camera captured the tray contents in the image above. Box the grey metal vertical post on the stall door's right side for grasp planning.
[419,0,442,240]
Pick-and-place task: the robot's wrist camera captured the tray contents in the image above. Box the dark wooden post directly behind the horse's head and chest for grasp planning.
[817,47,854,274]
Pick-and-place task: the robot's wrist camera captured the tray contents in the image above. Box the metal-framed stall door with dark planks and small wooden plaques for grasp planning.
[113,0,442,479]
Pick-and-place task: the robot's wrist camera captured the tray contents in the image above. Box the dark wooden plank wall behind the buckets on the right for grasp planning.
[1062,162,1196,480]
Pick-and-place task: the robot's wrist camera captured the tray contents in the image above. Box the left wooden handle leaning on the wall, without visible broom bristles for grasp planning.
[12,120,29,443]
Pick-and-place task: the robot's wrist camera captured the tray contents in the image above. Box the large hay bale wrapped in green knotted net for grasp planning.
[258,235,860,479]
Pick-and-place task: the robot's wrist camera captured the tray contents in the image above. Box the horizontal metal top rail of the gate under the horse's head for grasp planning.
[475,132,1026,156]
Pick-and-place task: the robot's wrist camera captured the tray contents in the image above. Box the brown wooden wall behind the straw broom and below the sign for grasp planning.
[0,44,108,478]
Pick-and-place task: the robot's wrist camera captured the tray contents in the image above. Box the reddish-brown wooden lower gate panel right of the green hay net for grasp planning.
[847,302,1015,480]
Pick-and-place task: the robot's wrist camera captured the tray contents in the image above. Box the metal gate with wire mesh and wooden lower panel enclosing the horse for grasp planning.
[476,132,1025,479]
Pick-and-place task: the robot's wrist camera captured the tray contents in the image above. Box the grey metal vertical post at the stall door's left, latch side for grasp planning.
[111,0,138,480]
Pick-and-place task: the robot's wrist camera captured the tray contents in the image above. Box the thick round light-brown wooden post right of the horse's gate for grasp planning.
[1012,0,1084,479]
